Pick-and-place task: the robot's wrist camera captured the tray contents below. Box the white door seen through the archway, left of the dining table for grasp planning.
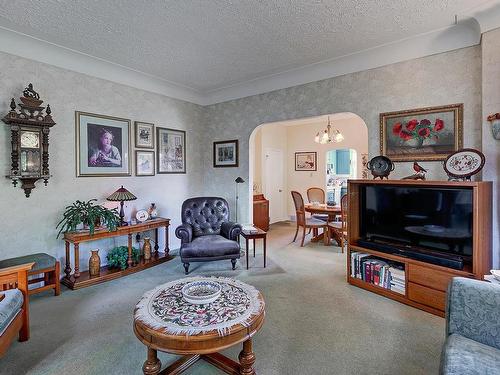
[264,149,285,223]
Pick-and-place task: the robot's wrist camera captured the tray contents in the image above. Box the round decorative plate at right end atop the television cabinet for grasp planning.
[443,148,485,178]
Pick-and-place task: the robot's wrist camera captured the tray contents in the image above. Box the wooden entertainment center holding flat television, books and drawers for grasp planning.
[347,180,492,316]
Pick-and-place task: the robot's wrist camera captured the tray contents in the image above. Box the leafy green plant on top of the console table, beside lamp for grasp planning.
[56,199,120,237]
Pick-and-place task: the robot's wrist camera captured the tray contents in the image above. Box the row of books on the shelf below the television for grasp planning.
[351,252,406,294]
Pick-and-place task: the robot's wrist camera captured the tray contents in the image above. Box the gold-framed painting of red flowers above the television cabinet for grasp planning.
[380,104,463,161]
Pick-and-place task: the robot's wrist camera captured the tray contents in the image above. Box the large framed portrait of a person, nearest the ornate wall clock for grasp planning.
[75,111,131,177]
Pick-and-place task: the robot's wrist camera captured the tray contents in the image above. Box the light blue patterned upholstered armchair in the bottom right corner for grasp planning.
[440,277,500,375]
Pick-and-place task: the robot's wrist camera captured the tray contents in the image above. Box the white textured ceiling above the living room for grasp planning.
[0,0,487,93]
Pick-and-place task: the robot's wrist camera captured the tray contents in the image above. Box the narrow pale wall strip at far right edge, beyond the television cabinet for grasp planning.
[481,29,500,268]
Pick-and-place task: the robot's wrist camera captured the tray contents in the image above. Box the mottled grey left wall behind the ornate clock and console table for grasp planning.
[0,53,203,269]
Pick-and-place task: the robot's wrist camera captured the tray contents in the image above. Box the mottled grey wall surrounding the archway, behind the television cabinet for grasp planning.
[203,46,481,231]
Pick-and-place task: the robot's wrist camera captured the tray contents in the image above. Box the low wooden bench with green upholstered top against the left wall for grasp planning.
[0,253,61,296]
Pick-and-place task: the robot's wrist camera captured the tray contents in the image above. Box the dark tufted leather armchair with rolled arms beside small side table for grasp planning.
[175,197,241,275]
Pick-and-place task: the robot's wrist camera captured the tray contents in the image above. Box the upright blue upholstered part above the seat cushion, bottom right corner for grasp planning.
[446,277,500,349]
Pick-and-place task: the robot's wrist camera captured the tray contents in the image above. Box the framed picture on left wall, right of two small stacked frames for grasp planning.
[156,127,186,173]
